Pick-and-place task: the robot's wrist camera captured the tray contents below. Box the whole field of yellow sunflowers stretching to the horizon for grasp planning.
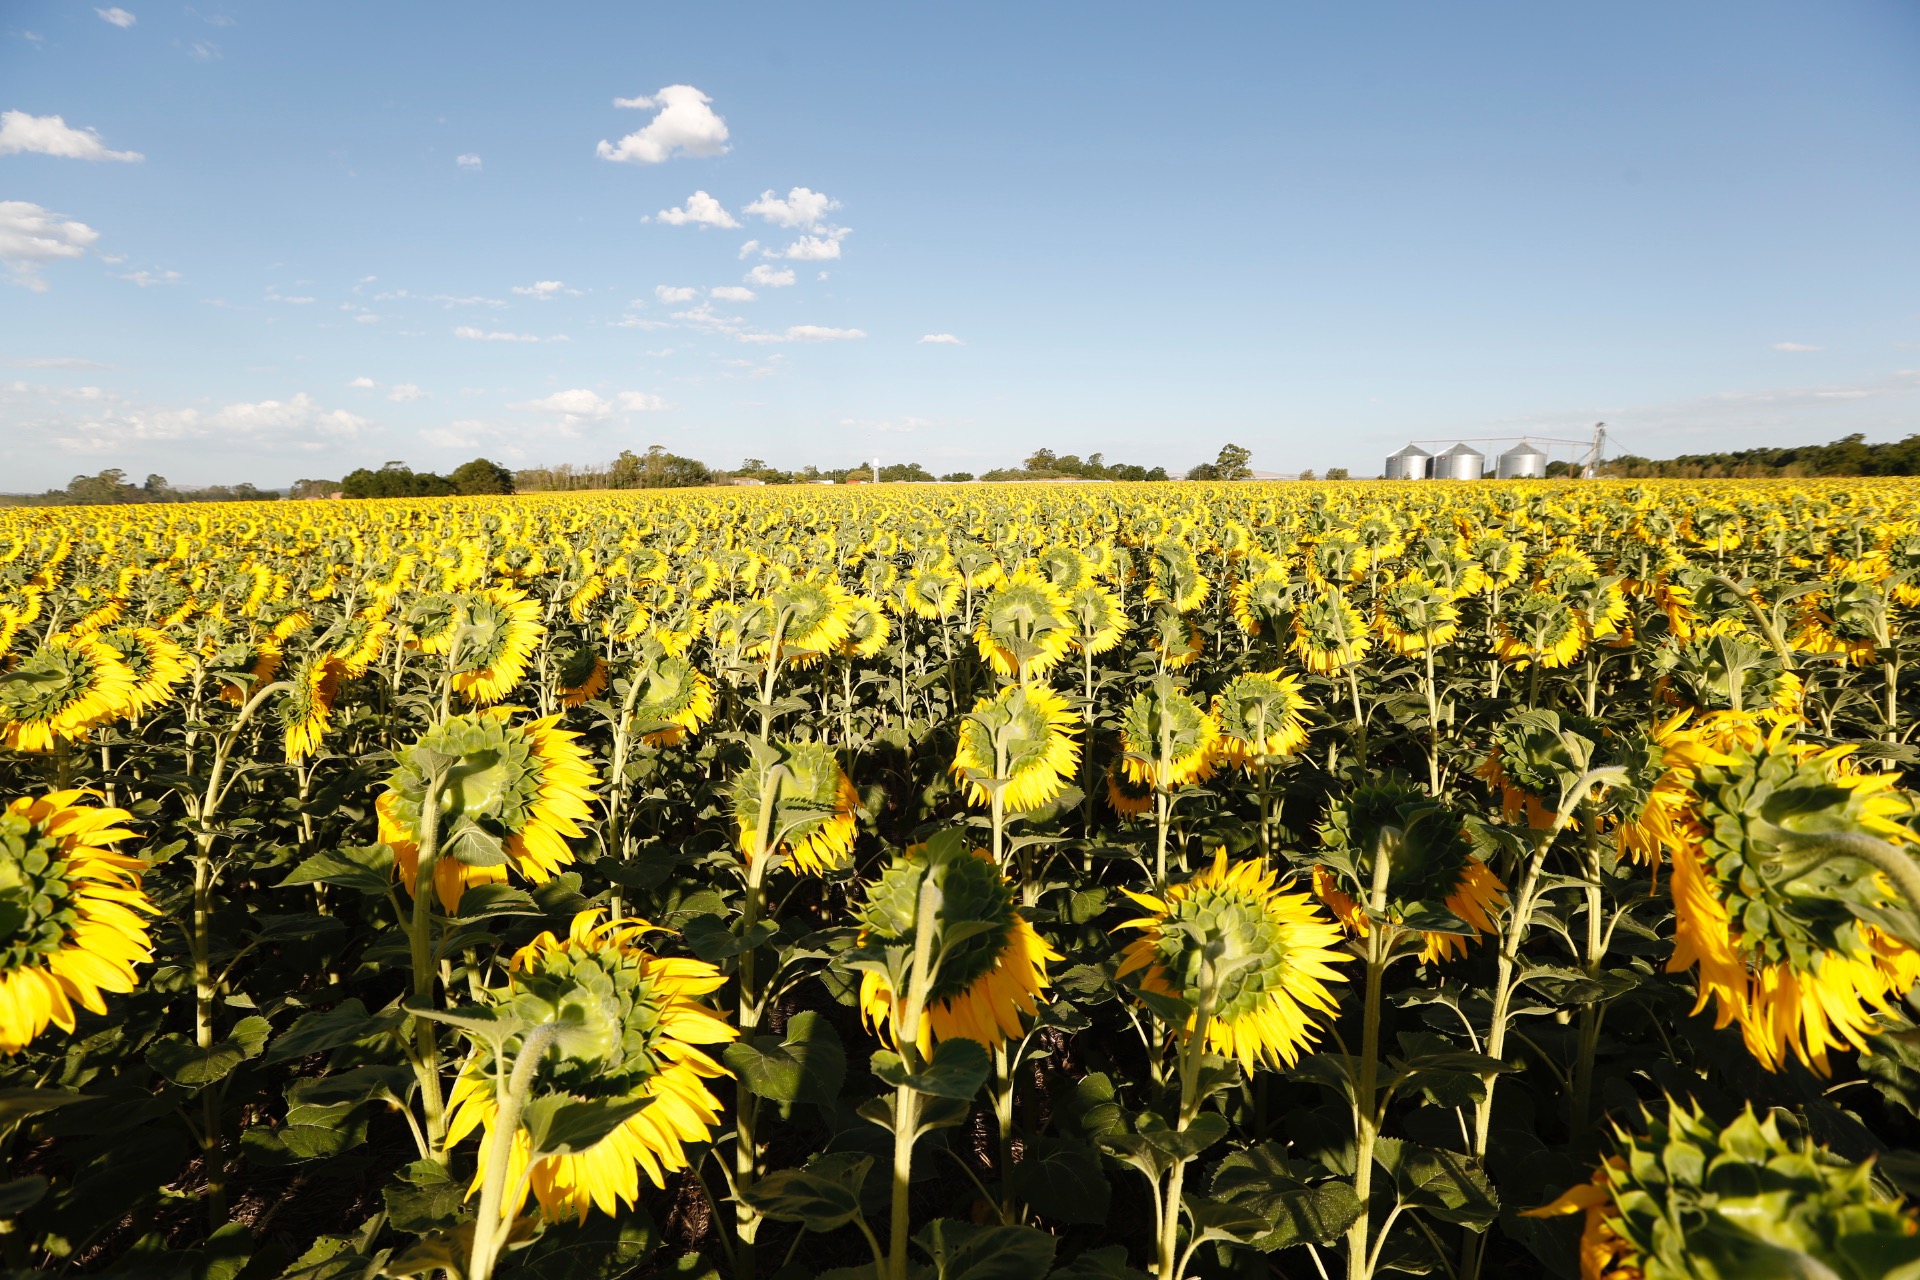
[0,480,1920,1280]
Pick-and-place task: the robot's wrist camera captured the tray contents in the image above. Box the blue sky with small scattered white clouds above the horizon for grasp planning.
[0,0,1920,489]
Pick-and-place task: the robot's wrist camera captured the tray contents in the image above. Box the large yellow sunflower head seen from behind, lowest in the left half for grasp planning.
[447,908,739,1222]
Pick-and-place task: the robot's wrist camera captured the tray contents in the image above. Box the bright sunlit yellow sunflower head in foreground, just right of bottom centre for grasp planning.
[1116,848,1346,1073]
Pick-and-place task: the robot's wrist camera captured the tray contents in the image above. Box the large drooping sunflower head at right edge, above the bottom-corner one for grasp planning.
[1667,720,1920,1075]
